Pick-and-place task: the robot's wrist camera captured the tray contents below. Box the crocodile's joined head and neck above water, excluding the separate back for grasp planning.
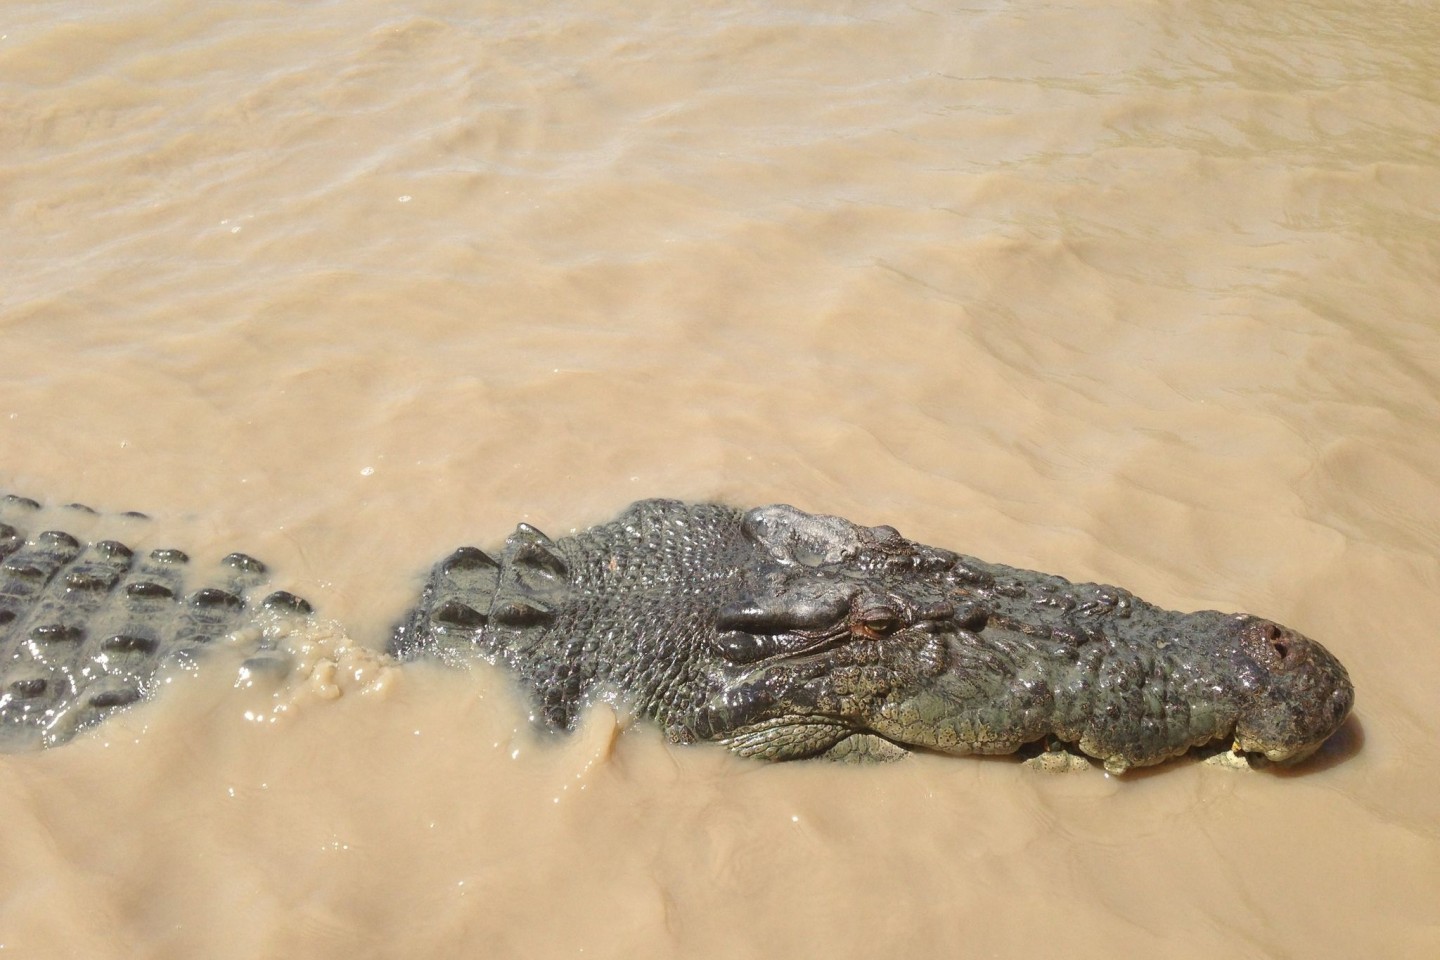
[393,501,1354,771]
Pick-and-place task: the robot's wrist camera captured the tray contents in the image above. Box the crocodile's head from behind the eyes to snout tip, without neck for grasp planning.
[685,507,1352,771]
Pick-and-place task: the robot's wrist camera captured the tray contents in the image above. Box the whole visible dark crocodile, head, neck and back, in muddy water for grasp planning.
[0,497,1354,771]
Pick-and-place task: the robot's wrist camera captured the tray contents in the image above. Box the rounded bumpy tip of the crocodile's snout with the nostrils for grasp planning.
[1236,615,1355,763]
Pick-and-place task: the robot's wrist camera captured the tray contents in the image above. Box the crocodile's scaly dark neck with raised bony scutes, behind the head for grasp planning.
[390,501,756,740]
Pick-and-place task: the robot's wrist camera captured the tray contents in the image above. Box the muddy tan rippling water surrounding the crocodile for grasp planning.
[0,0,1440,959]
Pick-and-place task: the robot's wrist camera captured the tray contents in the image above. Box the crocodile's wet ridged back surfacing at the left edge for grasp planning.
[0,497,310,753]
